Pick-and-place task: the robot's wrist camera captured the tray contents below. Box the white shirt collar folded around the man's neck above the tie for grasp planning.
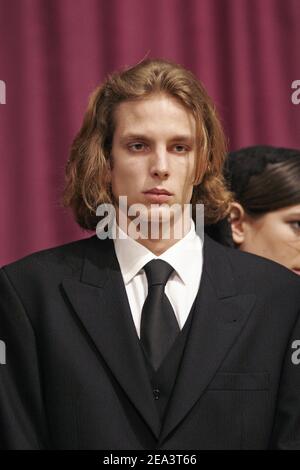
[113,219,203,285]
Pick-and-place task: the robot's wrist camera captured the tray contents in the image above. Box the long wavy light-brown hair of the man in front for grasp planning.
[62,59,232,230]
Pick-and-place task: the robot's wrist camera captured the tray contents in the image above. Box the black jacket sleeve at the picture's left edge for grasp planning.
[0,268,46,449]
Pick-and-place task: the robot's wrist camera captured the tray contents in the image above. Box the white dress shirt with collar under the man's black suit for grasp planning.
[113,219,203,338]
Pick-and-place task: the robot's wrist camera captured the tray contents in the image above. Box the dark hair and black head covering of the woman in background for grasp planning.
[206,146,300,247]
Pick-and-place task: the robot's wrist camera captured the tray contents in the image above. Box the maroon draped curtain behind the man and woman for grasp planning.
[0,0,300,265]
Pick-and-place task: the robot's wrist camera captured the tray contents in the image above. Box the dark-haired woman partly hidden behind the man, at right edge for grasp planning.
[207,146,300,275]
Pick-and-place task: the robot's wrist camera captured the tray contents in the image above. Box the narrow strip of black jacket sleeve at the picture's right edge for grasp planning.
[272,312,300,450]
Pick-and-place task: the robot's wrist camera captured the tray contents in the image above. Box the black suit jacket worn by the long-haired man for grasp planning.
[0,236,300,450]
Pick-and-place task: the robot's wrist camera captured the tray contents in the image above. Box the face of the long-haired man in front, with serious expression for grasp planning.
[111,94,196,229]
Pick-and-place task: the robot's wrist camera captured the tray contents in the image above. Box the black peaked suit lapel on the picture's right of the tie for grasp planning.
[159,236,255,445]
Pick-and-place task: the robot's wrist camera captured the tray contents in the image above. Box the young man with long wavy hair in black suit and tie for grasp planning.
[0,60,300,450]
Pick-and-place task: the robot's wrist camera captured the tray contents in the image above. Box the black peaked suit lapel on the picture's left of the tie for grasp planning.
[63,237,161,438]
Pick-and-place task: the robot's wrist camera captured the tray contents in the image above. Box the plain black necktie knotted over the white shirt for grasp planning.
[140,259,179,370]
